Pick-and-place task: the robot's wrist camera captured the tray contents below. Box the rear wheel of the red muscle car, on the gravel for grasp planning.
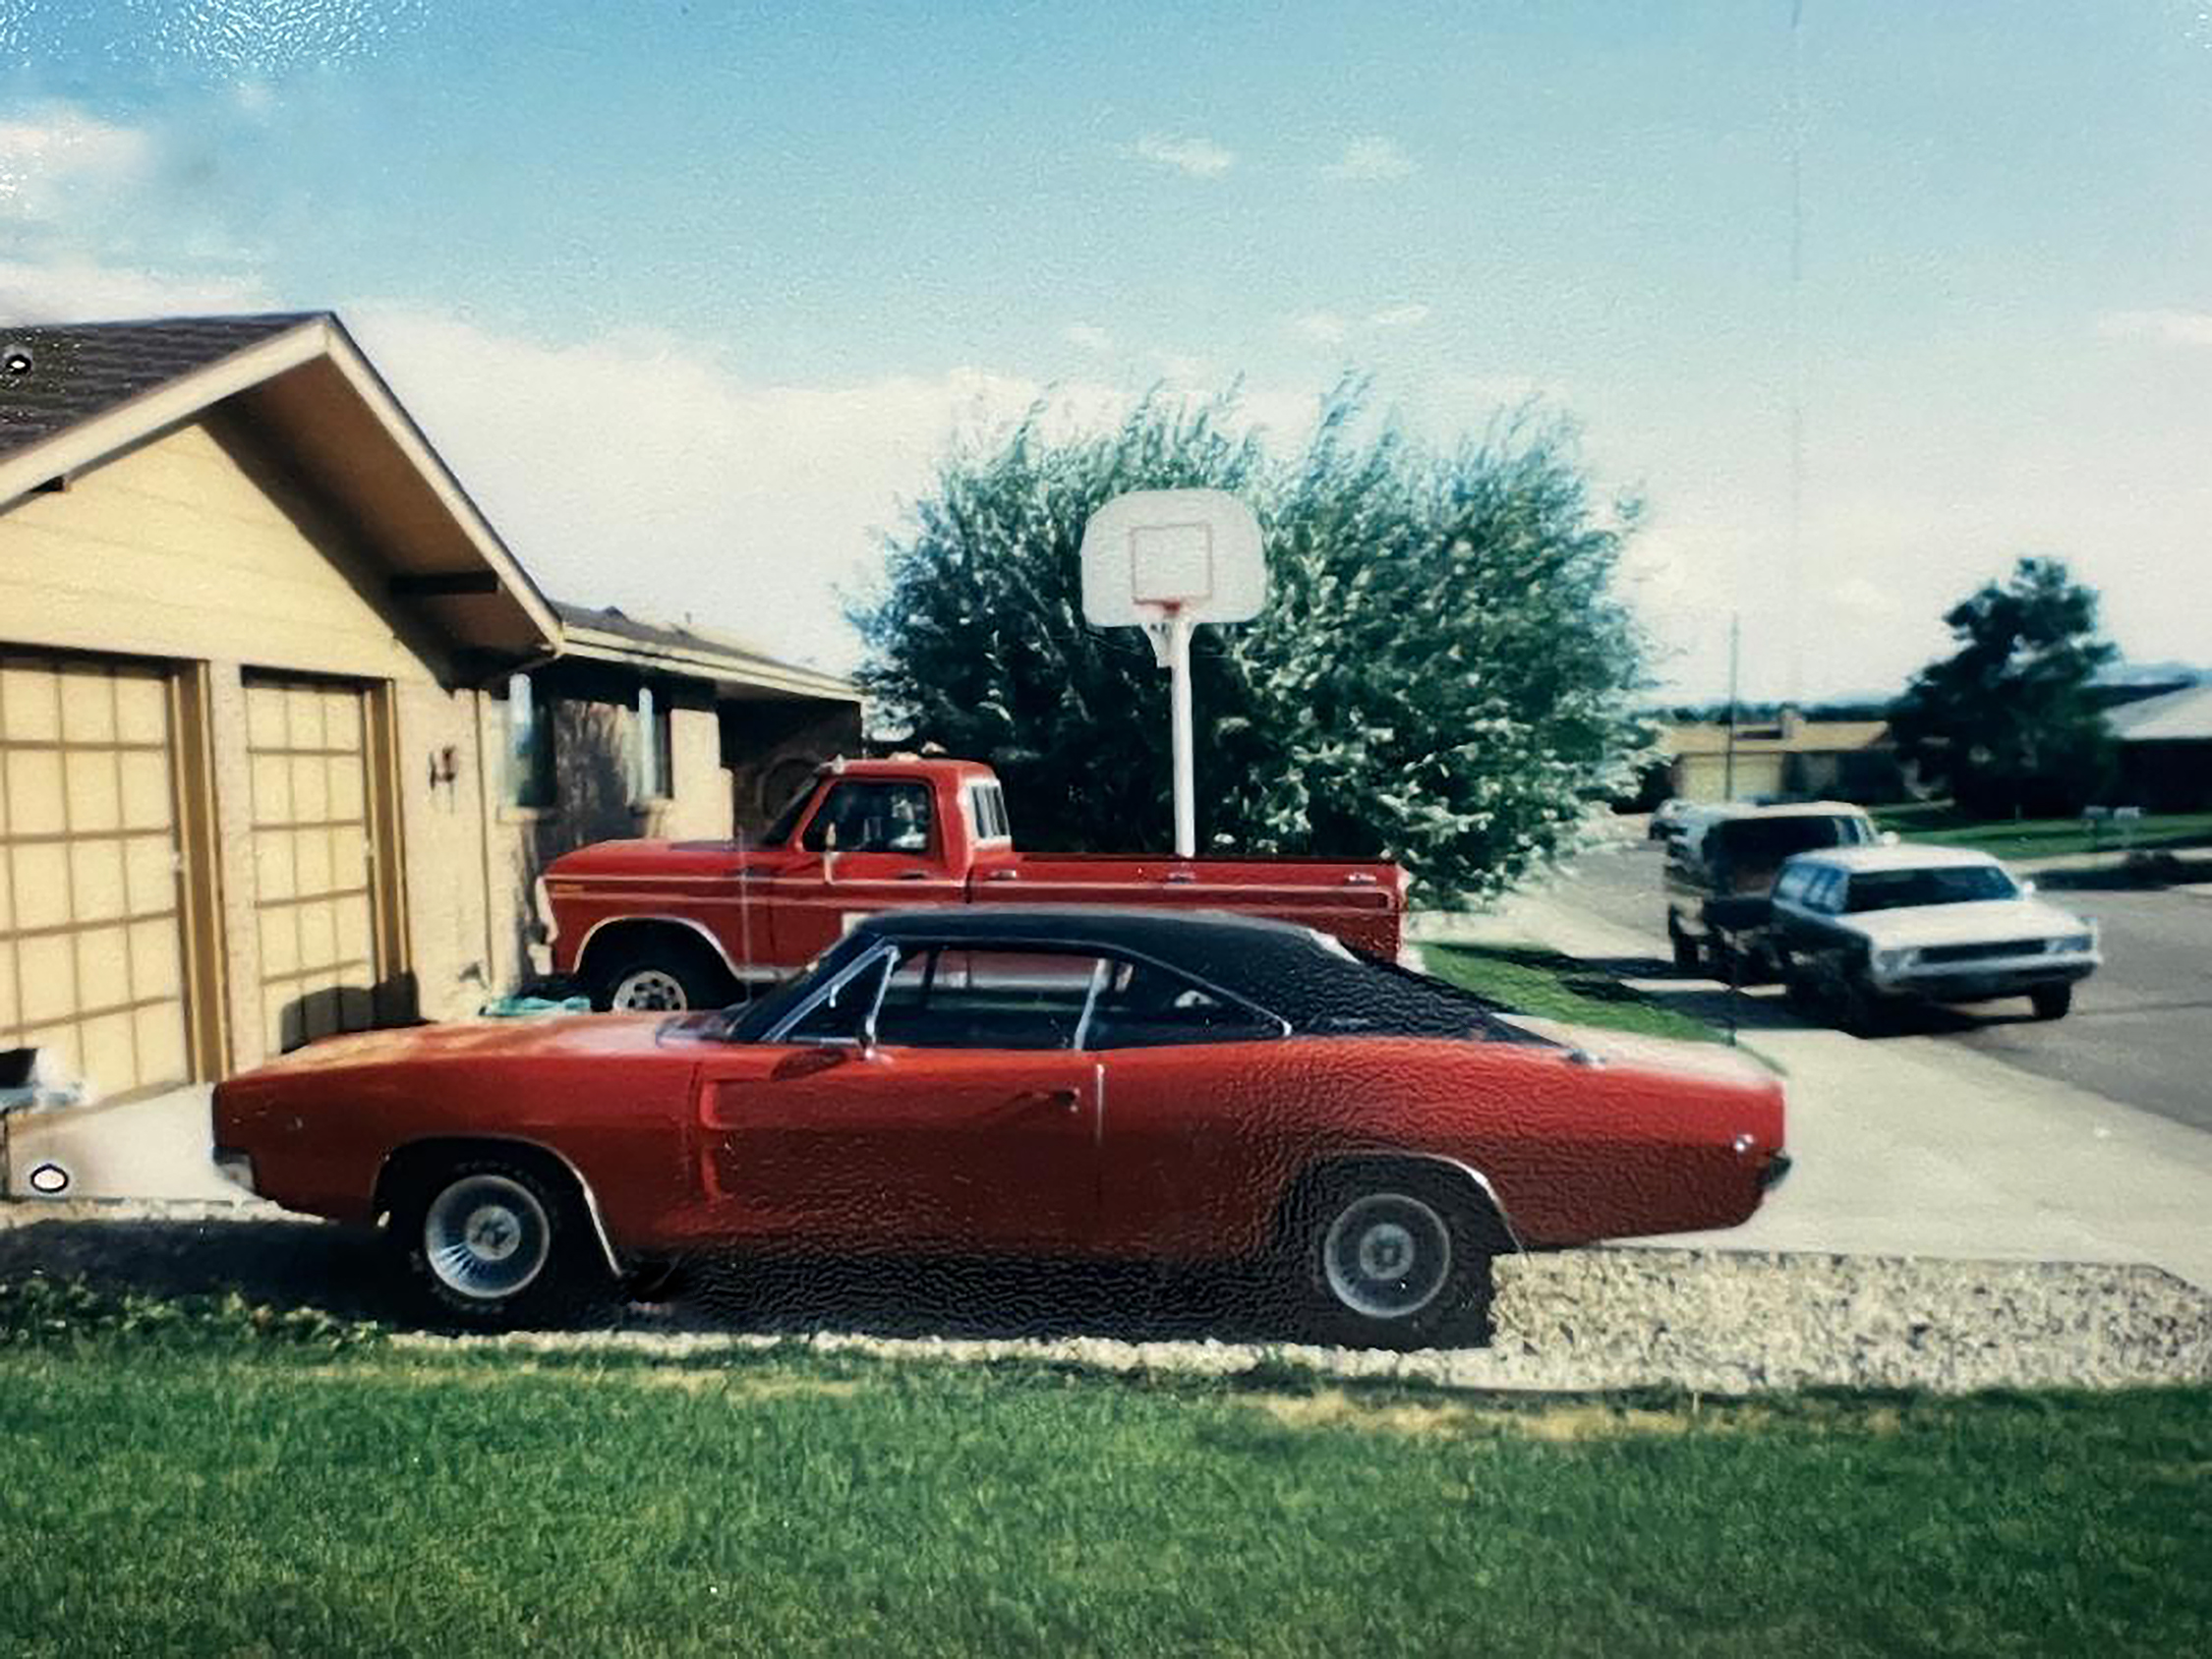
[1294,1166,1497,1347]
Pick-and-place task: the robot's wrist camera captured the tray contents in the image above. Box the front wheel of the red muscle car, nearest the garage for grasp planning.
[391,1157,607,1327]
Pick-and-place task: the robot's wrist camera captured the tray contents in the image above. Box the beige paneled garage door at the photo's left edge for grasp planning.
[0,653,193,1100]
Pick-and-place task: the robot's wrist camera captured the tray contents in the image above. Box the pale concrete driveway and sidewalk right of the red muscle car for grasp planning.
[1423,893,2212,1289]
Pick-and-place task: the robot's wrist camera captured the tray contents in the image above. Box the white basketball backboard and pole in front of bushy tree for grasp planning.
[1084,488,1267,858]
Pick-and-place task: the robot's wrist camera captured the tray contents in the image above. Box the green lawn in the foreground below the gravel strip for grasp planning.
[0,1327,2212,1659]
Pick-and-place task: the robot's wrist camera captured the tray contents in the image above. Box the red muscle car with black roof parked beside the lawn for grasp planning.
[214,907,1789,1347]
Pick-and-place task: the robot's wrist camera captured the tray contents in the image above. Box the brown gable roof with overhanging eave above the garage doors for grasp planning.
[0,312,559,657]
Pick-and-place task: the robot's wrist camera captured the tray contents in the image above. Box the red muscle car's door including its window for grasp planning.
[701,946,1097,1254]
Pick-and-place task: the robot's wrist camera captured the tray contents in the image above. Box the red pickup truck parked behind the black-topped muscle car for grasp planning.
[540,759,1405,1008]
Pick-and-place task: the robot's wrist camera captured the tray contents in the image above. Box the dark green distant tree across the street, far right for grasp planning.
[1890,559,2115,819]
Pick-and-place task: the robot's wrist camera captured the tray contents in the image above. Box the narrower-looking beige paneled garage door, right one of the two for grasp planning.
[246,677,382,1053]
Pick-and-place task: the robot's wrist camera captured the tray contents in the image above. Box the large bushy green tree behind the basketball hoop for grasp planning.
[854,385,1646,905]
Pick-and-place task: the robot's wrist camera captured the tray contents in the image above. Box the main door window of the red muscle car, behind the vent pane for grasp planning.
[876,944,1099,1049]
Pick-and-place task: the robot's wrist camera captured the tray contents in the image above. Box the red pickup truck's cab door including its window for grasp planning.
[770,778,966,962]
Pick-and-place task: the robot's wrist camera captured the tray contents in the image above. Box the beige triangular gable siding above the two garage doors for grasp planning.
[0,416,436,679]
